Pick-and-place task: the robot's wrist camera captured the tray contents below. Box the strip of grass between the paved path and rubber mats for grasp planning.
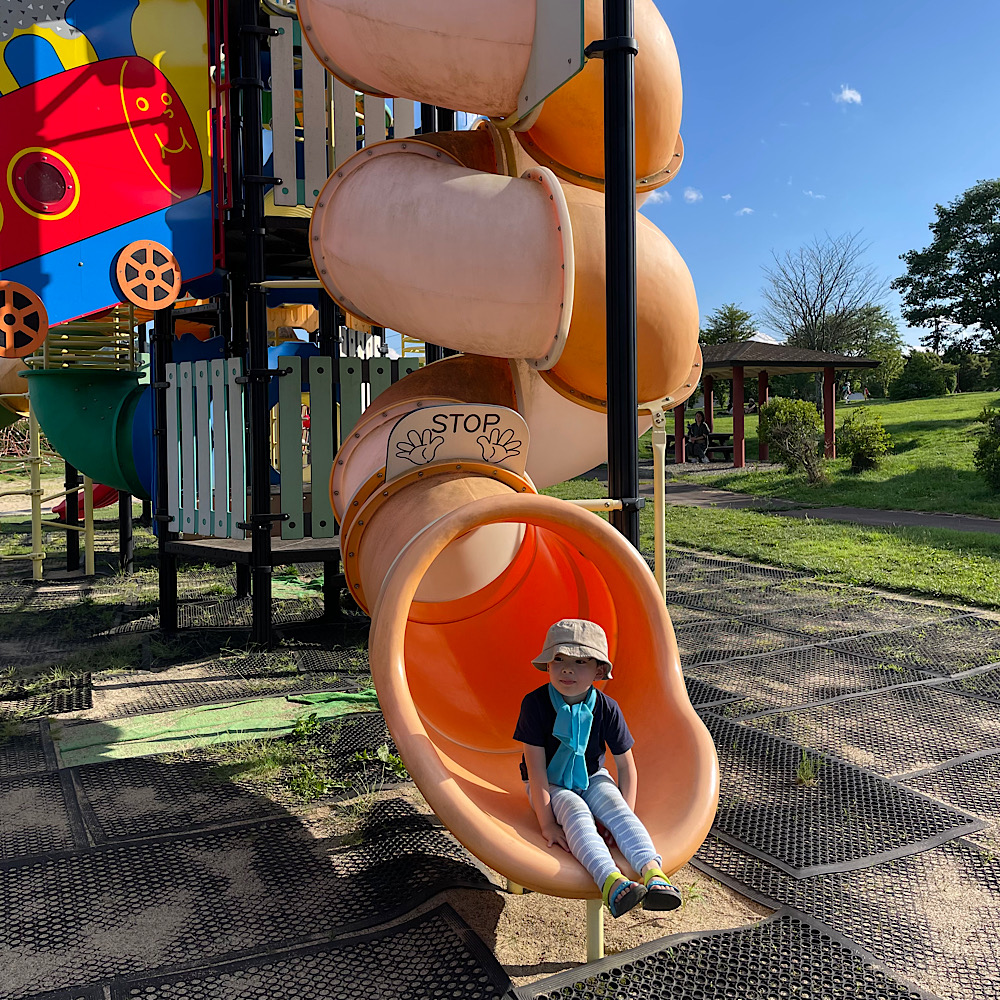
[542,479,1000,608]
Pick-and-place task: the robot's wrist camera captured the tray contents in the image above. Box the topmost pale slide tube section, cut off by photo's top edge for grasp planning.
[298,0,545,118]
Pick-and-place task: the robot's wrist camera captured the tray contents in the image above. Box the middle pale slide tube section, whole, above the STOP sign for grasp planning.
[310,139,575,368]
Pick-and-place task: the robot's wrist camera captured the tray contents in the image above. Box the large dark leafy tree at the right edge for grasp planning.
[892,179,1000,353]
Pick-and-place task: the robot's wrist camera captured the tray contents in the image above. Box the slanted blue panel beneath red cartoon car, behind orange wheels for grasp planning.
[0,192,215,323]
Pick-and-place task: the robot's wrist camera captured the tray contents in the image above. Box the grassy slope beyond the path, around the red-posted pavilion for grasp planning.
[640,392,1000,518]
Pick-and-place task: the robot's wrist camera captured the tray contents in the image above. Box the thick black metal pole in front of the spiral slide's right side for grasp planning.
[602,0,639,548]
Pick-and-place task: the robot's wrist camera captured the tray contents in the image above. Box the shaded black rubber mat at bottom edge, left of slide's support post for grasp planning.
[111,905,510,1000]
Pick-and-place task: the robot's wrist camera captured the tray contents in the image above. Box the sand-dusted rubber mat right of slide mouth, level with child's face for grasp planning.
[686,646,932,714]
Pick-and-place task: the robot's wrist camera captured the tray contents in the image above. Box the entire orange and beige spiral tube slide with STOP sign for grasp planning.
[299,0,718,898]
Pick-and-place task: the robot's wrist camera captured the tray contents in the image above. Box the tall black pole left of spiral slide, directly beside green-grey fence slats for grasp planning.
[240,0,272,646]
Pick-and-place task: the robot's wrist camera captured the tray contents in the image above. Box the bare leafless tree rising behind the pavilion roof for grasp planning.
[761,233,885,352]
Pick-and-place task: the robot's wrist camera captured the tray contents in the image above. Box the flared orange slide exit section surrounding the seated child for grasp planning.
[370,496,718,898]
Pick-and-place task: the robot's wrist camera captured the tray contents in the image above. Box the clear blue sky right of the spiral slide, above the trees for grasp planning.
[644,0,1000,343]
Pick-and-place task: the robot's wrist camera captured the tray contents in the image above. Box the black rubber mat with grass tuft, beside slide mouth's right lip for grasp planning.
[704,715,985,878]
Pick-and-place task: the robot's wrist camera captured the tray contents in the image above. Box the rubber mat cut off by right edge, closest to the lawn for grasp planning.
[835,615,1000,675]
